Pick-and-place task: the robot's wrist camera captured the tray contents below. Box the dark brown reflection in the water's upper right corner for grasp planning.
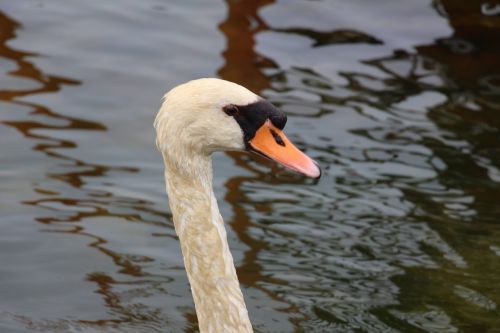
[417,0,500,110]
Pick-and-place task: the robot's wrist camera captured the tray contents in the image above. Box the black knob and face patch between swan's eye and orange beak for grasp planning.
[223,99,286,147]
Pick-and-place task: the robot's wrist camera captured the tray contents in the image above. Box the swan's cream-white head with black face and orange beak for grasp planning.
[155,78,321,178]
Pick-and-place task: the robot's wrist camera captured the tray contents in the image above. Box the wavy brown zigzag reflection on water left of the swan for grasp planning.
[0,12,171,331]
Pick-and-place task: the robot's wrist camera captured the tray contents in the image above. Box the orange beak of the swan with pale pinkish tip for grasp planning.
[248,119,321,179]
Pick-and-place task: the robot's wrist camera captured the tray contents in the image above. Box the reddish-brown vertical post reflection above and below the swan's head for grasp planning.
[218,0,302,321]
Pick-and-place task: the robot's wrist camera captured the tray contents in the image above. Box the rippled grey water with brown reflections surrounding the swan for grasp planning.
[0,0,500,333]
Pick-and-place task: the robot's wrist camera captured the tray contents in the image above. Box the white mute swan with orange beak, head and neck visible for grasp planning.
[154,78,321,333]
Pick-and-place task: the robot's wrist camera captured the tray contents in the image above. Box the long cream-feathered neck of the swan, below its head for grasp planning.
[164,154,253,333]
